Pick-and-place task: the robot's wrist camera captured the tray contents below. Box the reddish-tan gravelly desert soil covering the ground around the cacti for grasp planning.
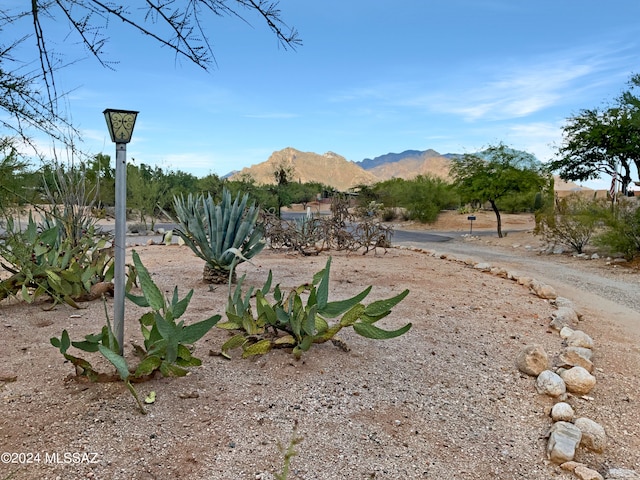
[0,215,640,480]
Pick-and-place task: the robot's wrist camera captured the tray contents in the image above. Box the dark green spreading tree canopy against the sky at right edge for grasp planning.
[549,75,640,193]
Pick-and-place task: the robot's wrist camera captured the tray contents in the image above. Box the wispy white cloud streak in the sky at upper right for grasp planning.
[330,46,630,122]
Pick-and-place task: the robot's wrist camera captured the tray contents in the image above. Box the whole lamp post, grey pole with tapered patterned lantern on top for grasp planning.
[103,108,138,355]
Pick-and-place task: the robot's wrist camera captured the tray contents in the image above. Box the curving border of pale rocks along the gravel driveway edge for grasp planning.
[395,246,640,480]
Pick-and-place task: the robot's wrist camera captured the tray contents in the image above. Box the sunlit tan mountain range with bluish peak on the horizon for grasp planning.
[228,147,456,191]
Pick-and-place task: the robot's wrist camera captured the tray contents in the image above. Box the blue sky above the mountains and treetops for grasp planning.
[10,0,640,185]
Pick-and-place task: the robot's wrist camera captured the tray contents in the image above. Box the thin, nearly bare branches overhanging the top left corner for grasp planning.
[0,0,301,152]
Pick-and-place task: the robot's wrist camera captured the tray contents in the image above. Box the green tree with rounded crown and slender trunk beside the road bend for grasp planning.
[451,143,551,238]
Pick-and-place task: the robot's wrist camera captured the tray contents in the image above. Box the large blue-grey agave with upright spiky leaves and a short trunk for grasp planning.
[173,188,265,284]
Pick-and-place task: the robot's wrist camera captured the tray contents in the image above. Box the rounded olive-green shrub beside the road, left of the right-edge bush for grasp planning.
[538,195,606,253]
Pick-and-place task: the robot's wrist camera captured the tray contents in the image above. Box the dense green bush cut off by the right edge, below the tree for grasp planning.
[594,200,640,260]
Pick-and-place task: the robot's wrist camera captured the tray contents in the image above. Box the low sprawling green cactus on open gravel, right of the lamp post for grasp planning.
[217,257,411,359]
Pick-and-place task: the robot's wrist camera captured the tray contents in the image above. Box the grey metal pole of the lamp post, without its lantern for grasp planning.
[113,143,127,355]
